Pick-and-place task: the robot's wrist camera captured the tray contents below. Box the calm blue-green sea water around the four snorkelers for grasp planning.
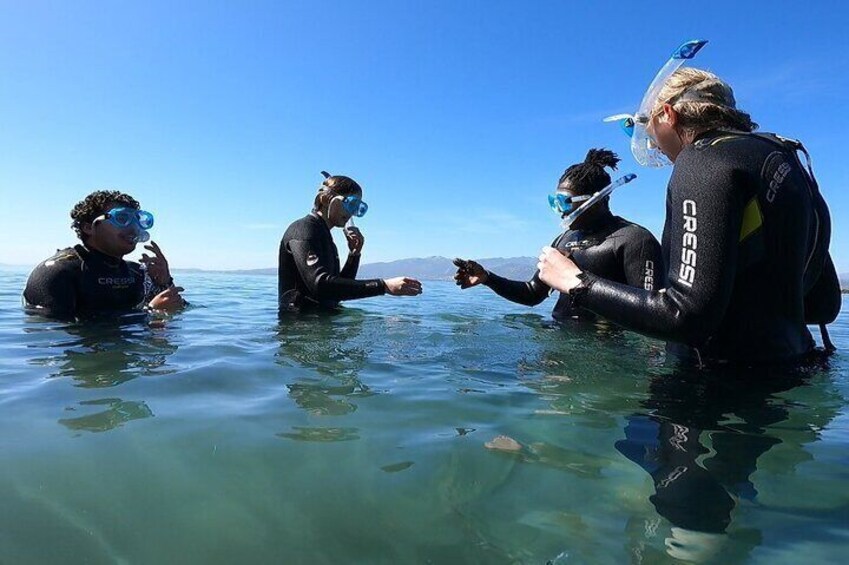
[0,268,849,565]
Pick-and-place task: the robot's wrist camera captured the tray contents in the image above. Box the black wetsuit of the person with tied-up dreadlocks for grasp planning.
[484,210,664,320]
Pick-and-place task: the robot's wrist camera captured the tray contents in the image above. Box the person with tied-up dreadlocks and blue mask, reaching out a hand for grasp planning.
[454,149,664,321]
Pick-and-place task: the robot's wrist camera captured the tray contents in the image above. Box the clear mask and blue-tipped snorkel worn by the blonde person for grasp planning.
[604,39,707,167]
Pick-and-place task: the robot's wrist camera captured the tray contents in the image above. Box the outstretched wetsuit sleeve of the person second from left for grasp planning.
[289,239,386,301]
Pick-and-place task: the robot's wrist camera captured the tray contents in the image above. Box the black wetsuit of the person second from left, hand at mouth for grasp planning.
[277,213,386,313]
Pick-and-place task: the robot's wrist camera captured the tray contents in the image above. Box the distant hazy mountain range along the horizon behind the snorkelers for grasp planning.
[174,257,537,281]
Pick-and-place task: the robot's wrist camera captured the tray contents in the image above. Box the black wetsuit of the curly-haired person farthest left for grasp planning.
[23,245,165,320]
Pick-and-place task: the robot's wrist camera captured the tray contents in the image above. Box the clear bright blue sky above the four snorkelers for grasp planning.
[0,0,849,272]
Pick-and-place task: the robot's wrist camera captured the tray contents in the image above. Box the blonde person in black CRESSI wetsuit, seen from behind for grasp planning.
[539,42,840,365]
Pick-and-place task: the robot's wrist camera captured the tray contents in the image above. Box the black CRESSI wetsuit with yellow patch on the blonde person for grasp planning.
[573,131,840,364]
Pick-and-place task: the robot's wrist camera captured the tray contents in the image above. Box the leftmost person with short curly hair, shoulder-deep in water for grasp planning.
[23,190,185,320]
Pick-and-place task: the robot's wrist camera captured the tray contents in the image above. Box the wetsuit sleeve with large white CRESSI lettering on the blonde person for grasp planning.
[573,153,744,344]
